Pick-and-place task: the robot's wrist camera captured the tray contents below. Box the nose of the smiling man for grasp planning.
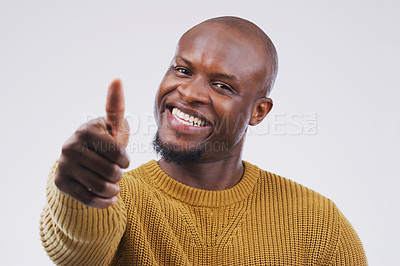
[177,78,210,104]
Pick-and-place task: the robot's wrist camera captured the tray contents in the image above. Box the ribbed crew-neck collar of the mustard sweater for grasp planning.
[143,160,260,207]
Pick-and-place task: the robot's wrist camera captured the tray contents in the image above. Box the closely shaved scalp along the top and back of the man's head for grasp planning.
[181,16,278,96]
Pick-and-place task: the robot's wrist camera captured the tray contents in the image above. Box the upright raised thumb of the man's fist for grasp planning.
[106,79,125,136]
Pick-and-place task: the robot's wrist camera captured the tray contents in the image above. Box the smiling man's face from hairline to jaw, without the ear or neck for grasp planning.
[155,23,266,160]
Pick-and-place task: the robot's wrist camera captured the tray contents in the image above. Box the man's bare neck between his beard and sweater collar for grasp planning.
[158,153,244,190]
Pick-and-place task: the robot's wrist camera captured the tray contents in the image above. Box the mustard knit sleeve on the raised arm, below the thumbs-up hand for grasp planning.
[40,163,127,265]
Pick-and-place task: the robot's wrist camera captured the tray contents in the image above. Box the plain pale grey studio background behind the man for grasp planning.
[0,0,400,265]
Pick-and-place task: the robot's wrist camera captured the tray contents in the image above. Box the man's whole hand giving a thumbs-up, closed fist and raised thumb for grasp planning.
[54,79,129,209]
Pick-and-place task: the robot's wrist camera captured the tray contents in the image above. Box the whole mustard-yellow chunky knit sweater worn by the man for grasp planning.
[40,161,367,266]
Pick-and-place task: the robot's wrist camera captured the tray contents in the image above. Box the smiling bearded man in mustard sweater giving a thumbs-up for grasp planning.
[41,17,366,265]
